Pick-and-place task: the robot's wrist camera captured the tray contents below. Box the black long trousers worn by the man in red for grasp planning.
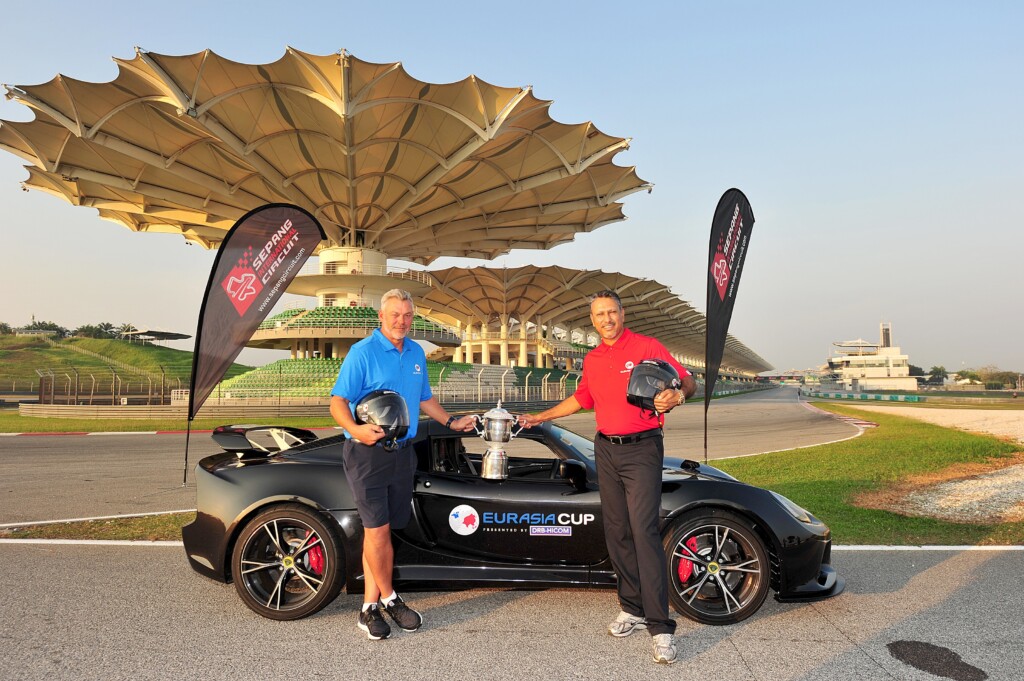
[594,436,676,636]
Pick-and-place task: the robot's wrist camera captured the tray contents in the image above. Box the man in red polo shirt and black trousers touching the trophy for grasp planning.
[519,291,696,665]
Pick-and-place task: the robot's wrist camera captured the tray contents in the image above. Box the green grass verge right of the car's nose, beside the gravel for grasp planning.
[716,402,1024,545]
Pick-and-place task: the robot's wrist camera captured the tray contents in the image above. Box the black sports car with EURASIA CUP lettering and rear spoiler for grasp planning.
[181,422,845,625]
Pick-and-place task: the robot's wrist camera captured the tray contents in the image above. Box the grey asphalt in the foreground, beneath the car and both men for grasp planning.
[0,543,1024,681]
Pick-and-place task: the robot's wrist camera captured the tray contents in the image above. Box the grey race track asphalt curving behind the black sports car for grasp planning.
[0,388,858,524]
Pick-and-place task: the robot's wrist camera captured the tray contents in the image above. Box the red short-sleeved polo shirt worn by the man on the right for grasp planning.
[572,329,690,435]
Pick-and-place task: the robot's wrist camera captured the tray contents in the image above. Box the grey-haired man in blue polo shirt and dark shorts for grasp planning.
[331,289,474,640]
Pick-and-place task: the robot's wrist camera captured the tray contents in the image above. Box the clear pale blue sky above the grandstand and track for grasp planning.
[0,0,1024,371]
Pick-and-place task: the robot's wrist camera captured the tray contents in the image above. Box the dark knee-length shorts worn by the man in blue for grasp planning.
[342,439,416,529]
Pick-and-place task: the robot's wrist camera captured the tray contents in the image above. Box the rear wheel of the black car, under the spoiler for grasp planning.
[231,504,345,620]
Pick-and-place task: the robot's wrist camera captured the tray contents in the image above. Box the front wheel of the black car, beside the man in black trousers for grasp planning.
[665,509,771,625]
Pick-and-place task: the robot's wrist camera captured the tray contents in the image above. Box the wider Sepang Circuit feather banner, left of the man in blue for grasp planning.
[188,204,325,422]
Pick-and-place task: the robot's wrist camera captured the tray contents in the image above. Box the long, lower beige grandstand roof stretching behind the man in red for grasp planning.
[417,265,772,374]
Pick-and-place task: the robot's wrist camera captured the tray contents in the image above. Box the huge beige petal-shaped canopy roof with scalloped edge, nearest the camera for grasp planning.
[0,48,650,263]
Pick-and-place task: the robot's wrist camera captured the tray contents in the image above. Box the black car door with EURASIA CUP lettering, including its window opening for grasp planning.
[415,436,607,565]
